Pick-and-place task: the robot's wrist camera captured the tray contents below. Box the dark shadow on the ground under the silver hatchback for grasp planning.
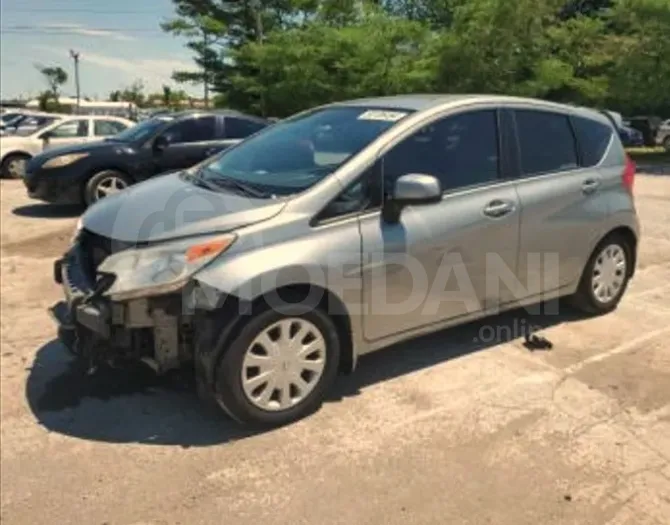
[26,302,577,447]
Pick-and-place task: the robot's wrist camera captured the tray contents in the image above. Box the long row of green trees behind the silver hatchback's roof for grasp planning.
[163,0,670,116]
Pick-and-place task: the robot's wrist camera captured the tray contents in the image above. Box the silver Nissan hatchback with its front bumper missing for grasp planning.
[51,95,639,426]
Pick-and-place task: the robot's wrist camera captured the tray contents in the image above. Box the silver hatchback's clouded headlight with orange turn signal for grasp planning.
[98,234,235,301]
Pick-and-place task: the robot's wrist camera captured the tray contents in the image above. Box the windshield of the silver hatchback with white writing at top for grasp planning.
[199,106,410,195]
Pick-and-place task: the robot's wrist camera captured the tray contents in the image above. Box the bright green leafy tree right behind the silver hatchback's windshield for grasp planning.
[226,5,434,116]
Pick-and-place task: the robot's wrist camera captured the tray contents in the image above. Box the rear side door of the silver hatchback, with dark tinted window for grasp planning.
[513,108,613,299]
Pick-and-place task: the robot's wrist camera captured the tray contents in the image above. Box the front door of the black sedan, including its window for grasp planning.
[153,115,223,174]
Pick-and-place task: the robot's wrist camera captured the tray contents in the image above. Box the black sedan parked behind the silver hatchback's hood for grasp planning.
[24,111,269,206]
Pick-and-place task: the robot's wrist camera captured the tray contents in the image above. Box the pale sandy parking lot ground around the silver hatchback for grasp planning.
[0,175,670,525]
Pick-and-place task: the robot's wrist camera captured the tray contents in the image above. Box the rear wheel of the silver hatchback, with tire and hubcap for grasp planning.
[570,234,633,315]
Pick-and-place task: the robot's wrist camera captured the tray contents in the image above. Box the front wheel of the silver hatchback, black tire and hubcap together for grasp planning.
[215,304,340,427]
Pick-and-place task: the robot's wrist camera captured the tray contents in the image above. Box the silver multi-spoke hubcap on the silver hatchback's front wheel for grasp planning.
[242,318,326,411]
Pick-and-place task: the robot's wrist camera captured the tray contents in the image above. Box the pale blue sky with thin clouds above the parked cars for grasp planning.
[0,0,202,100]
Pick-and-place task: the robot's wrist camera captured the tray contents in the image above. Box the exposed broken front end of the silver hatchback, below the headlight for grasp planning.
[50,247,192,373]
